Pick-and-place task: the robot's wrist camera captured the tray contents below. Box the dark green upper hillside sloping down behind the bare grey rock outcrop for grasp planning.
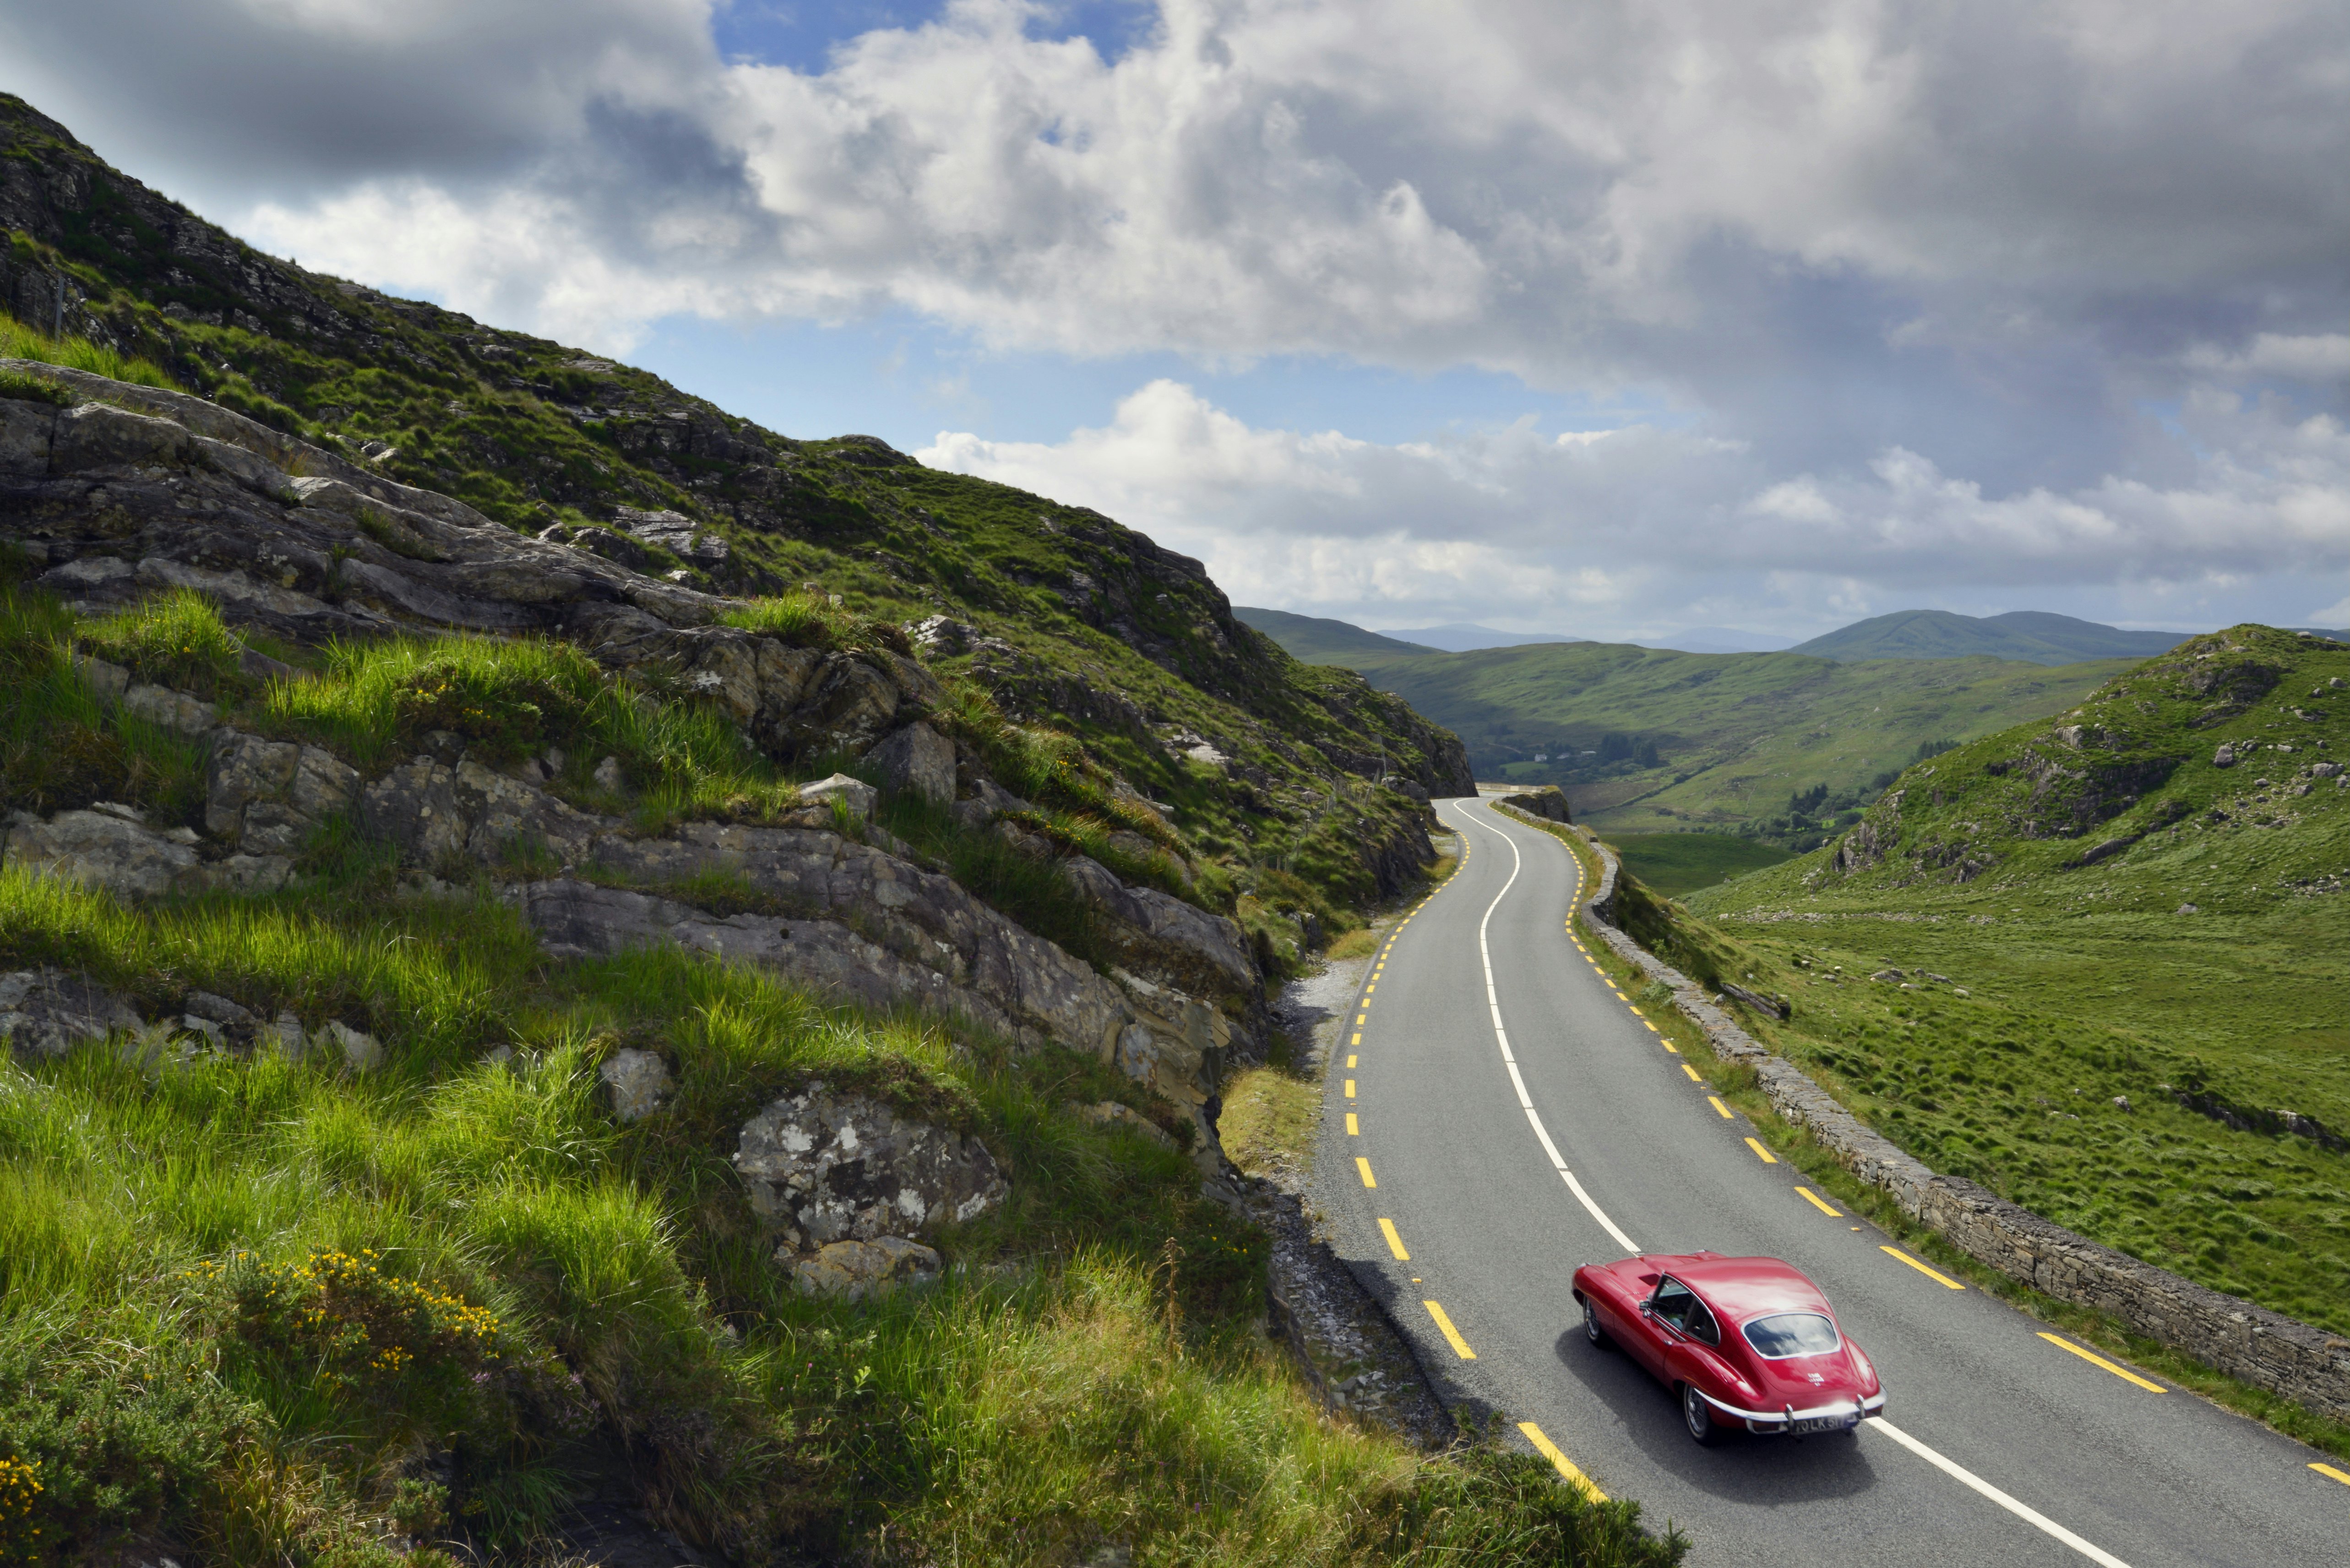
[0,97,1471,924]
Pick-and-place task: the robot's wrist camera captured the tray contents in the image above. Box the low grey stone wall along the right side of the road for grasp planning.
[1494,804,2350,1422]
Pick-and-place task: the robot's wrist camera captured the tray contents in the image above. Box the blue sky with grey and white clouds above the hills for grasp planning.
[0,0,2350,637]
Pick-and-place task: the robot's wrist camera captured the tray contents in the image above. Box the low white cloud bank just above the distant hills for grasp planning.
[916,381,2350,630]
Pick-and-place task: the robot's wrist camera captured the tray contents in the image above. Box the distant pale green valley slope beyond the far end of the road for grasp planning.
[1354,642,2127,832]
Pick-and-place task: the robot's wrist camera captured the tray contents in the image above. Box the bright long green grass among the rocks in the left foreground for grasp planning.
[0,592,1678,1568]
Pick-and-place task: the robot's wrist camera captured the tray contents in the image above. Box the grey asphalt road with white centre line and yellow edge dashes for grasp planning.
[1316,799,2350,1568]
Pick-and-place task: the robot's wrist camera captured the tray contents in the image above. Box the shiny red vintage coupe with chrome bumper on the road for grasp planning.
[1574,1253,1885,1446]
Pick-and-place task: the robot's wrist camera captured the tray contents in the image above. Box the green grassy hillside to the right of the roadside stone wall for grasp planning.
[1650,628,2350,1333]
